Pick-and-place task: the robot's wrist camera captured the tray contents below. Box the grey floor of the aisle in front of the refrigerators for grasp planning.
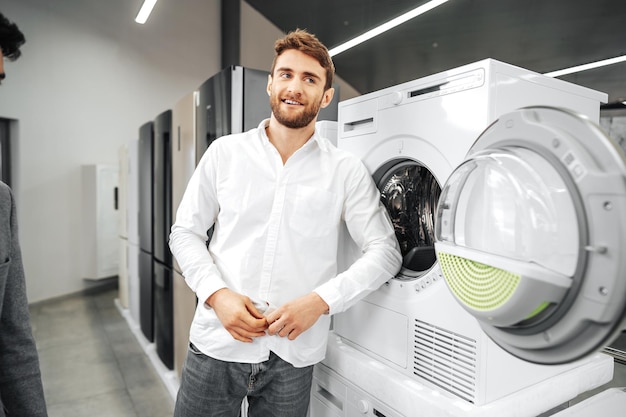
[31,289,174,417]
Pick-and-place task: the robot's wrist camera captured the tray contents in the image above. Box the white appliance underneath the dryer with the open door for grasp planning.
[310,332,613,417]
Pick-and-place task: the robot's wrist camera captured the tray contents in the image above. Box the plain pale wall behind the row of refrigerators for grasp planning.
[0,0,220,302]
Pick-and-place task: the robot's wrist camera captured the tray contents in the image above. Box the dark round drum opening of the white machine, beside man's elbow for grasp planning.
[374,159,441,280]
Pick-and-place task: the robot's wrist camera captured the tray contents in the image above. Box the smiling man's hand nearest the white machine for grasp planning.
[266,292,328,340]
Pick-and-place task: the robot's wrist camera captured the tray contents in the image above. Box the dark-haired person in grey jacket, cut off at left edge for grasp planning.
[0,10,48,417]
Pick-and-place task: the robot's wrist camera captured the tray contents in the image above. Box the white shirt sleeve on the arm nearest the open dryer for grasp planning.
[315,160,402,314]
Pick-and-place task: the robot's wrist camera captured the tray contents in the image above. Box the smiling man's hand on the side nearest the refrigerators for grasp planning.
[206,288,267,343]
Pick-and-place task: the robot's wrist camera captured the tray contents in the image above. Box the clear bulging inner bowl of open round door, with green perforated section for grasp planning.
[436,145,582,328]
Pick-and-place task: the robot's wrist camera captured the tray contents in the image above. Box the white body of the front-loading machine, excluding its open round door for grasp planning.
[327,59,606,406]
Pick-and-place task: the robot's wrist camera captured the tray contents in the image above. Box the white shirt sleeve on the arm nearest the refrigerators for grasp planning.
[169,146,226,303]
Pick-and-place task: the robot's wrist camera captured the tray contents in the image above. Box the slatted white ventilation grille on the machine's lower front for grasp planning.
[413,320,477,403]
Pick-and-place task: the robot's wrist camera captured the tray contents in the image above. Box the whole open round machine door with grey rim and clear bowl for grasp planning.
[435,107,626,364]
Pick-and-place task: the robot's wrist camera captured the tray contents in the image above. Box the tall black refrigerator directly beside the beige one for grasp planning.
[152,110,174,369]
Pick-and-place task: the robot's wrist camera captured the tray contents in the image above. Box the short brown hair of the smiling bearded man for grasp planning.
[271,29,335,91]
